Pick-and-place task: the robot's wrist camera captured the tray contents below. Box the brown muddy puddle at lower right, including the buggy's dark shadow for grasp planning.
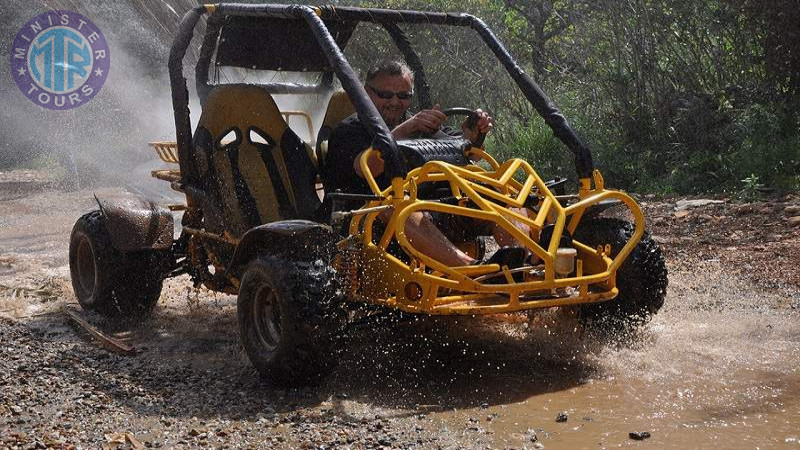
[324,262,800,448]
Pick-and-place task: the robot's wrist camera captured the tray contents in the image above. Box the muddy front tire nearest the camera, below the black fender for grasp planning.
[237,257,340,386]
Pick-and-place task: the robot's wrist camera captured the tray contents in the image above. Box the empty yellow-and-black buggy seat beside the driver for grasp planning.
[192,84,320,237]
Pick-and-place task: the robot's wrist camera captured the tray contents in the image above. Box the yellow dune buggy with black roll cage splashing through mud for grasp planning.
[70,4,667,383]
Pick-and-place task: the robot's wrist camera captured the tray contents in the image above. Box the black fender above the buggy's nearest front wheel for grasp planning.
[228,220,337,274]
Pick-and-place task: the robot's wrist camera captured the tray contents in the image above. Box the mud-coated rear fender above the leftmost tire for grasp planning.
[94,193,175,252]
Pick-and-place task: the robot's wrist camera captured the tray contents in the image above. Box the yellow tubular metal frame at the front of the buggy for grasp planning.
[340,148,644,314]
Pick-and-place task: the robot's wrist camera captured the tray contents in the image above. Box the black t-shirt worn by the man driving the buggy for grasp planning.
[324,114,461,208]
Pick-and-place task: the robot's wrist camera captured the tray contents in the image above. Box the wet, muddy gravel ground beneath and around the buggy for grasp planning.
[0,171,800,449]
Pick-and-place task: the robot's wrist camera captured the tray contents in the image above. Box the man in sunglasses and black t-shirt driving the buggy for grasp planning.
[325,61,527,266]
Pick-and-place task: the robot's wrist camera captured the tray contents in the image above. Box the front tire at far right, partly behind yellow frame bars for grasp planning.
[573,217,667,332]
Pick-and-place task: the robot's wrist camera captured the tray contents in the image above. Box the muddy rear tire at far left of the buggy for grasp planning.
[69,211,166,322]
